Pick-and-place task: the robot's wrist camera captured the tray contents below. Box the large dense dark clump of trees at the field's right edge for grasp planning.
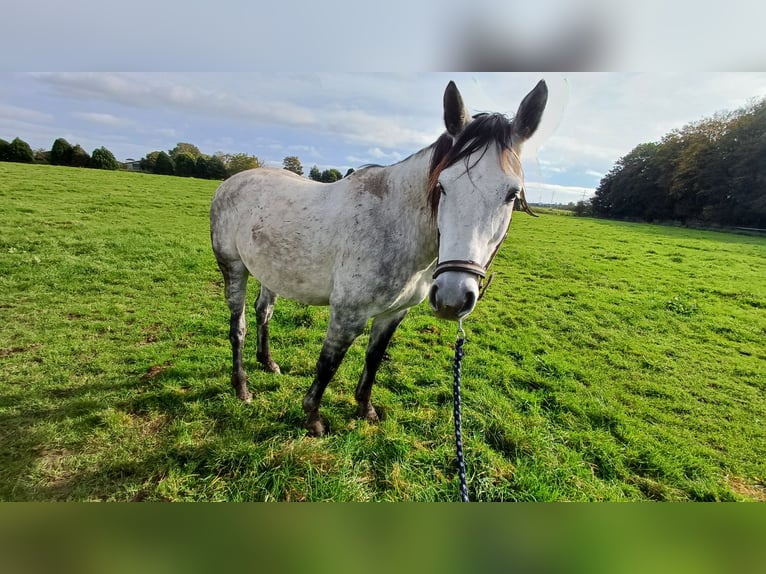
[588,98,766,229]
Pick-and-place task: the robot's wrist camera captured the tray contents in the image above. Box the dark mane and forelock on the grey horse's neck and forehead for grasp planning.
[428,113,513,217]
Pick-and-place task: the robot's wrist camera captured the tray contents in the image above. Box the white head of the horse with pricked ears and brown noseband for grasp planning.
[428,80,548,320]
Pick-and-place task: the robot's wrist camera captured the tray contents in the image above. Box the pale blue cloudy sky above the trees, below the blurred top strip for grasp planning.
[0,72,766,203]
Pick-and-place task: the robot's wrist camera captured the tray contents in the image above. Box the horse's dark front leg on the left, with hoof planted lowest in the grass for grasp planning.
[303,309,368,436]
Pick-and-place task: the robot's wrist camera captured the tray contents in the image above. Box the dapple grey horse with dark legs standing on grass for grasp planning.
[210,80,548,435]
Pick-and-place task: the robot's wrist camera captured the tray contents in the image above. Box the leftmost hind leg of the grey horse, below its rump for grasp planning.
[218,260,252,403]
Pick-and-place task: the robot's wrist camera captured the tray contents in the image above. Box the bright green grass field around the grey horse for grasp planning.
[0,163,766,501]
